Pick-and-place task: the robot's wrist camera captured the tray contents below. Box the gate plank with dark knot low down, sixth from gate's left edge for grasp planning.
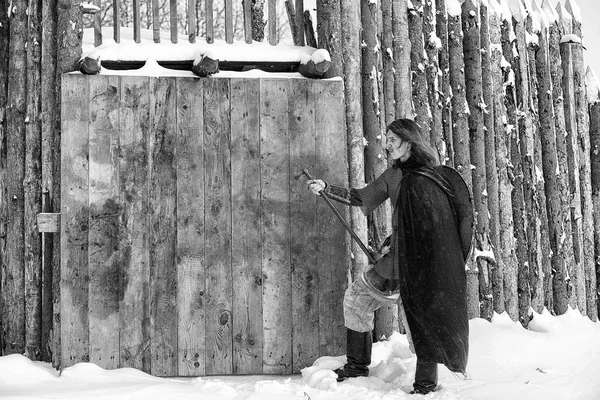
[204,79,233,375]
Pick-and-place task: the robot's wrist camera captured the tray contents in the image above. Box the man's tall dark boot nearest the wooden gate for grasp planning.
[334,329,373,382]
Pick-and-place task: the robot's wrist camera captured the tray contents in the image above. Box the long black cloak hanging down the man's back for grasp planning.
[396,159,473,373]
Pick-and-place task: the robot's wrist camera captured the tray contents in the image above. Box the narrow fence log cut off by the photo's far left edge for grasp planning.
[0,0,10,355]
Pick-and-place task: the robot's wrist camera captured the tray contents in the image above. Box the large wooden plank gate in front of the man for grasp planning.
[61,74,349,376]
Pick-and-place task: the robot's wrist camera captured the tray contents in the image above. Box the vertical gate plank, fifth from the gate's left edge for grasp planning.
[176,78,206,376]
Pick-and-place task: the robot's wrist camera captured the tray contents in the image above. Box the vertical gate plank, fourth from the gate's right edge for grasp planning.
[231,79,263,374]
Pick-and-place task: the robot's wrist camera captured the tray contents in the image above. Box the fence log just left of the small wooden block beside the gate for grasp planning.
[23,0,42,360]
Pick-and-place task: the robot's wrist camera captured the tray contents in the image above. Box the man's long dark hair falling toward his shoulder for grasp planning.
[387,118,440,167]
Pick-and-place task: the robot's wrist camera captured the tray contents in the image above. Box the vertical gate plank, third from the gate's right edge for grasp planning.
[260,79,292,374]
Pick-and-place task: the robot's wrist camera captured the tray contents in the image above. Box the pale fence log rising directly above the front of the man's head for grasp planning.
[392,0,414,119]
